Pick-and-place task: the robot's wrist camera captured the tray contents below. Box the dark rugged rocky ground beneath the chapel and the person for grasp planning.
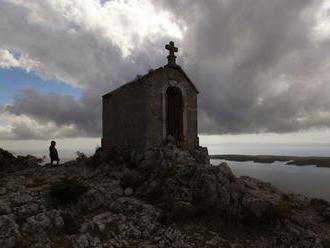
[0,143,330,248]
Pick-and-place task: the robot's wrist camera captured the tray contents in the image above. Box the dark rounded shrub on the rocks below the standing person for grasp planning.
[49,177,88,205]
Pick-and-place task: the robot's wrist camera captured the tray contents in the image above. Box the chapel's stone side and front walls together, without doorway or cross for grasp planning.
[102,67,198,149]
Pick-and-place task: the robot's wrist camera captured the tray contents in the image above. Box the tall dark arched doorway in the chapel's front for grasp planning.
[166,86,184,144]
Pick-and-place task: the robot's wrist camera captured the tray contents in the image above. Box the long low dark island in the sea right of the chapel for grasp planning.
[210,154,330,168]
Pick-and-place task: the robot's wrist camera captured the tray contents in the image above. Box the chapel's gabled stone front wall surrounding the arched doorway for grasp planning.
[146,67,198,147]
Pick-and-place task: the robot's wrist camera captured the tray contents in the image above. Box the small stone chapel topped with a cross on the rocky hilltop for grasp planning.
[102,41,199,149]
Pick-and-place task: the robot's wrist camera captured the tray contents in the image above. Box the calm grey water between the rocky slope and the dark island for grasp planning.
[211,159,330,201]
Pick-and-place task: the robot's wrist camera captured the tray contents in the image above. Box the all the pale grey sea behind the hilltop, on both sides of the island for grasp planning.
[8,143,330,201]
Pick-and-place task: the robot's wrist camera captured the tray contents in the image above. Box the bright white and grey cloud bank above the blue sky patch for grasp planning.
[0,0,181,88]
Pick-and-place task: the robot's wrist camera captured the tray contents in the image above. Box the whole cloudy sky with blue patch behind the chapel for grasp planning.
[0,0,330,154]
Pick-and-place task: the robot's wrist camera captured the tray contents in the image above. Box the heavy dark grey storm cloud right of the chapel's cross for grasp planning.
[155,0,330,133]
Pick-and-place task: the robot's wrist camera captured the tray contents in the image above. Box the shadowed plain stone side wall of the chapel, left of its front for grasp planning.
[102,81,147,149]
